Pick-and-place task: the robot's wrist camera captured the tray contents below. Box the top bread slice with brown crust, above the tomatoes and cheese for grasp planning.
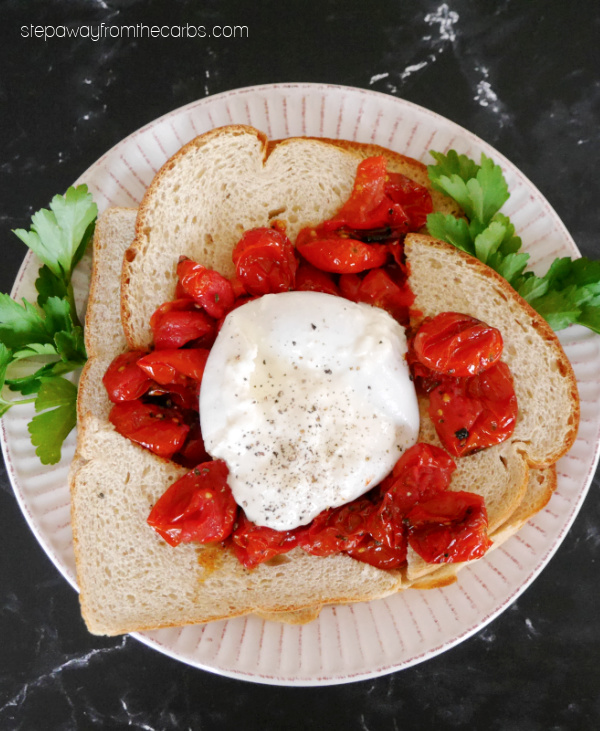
[122,125,458,348]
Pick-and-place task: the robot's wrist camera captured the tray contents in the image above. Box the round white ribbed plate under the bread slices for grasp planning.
[2,84,600,685]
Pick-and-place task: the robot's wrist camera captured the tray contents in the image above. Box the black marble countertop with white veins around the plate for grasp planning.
[0,0,600,731]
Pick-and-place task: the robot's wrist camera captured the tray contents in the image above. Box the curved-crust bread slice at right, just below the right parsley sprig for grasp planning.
[405,234,579,467]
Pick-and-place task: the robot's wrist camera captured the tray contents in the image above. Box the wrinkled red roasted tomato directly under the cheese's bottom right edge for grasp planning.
[299,498,374,556]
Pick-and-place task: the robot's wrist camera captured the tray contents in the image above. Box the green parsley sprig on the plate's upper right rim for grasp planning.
[427,150,600,332]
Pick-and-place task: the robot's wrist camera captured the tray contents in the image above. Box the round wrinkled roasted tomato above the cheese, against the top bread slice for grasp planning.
[233,228,298,295]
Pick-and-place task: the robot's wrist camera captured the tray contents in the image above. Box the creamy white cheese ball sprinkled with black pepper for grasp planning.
[200,292,419,530]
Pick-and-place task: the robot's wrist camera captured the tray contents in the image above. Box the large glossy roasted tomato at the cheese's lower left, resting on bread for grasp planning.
[148,460,237,546]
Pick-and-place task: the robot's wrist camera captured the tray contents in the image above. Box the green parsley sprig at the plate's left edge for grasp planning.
[0,185,98,464]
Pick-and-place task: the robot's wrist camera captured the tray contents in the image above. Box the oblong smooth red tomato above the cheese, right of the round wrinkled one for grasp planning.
[296,234,388,274]
